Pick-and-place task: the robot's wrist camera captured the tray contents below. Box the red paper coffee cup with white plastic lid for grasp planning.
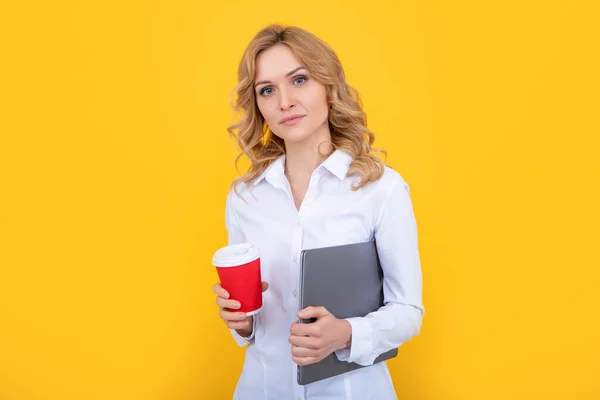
[212,243,263,315]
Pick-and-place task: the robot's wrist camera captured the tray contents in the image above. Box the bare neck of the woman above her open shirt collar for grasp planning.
[285,125,331,182]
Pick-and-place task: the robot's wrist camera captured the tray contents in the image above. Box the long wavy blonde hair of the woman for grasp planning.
[227,24,387,190]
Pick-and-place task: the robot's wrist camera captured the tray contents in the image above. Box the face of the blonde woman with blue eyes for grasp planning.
[255,44,330,145]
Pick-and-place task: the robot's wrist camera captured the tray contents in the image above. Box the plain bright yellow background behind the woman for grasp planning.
[0,0,600,400]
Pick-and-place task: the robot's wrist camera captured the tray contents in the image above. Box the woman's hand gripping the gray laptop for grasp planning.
[289,307,352,366]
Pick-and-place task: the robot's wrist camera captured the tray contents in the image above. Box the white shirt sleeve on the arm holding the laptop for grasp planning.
[335,178,425,366]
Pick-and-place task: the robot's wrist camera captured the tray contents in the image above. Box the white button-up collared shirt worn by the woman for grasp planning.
[226,150,424,400]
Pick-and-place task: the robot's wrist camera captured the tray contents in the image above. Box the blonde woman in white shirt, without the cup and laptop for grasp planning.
[213,25,424,400]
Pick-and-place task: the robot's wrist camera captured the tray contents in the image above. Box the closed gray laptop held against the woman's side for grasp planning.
[298,241,398,385]
